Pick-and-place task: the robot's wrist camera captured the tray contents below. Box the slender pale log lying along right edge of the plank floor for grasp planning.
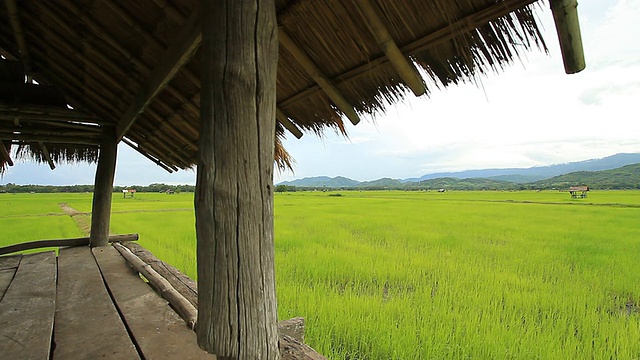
[113,243,198,329]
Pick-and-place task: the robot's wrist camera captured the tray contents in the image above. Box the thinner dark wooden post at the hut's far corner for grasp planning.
[89,125,118,247]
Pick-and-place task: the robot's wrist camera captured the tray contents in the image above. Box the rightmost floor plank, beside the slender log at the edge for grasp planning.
[92,246,216,359]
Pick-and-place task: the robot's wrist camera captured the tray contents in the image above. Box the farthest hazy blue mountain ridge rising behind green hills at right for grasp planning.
[400,153,640,183]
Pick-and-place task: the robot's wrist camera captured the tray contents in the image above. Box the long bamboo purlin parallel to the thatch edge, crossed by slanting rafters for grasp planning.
[278,0,538,108]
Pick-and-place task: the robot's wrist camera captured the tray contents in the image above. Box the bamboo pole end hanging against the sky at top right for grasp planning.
[551,0,586,74]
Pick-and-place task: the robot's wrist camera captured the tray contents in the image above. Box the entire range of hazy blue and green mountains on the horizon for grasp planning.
[277,153,640,189]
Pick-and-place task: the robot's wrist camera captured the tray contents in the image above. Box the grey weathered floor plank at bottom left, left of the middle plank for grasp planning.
[0,251,57,359]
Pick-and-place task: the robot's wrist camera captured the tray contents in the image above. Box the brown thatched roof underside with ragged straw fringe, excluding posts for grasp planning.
[0,0,545,171]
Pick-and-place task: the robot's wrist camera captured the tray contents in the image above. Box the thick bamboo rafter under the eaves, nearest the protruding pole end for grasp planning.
[354,0,427,96]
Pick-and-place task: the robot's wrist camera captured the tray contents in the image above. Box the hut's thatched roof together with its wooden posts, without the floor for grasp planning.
[0,0,582,359]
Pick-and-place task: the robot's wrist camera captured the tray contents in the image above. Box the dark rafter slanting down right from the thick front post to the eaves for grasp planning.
[278,27,360,125]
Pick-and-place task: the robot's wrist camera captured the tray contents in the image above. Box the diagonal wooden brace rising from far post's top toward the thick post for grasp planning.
[117,6,202,140]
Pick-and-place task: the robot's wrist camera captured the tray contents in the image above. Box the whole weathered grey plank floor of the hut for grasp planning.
[0,246,215,360]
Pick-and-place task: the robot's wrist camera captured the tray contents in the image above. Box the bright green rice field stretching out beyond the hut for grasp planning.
[0,191,640,359]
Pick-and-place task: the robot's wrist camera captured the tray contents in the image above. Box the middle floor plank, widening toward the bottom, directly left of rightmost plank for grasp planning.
[53,246,140,359]
